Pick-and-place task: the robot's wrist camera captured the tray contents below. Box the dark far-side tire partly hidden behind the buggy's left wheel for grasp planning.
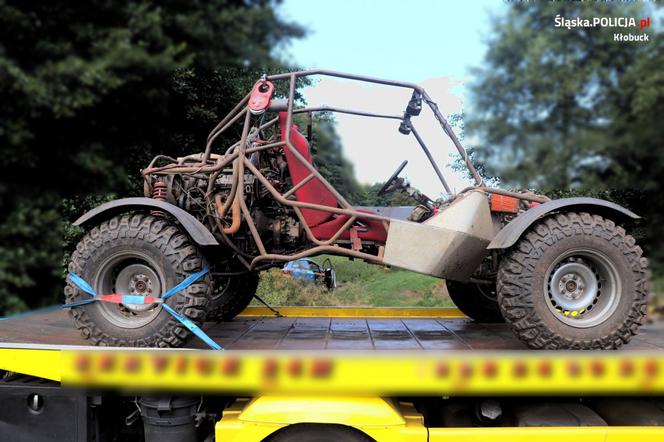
[207,272,258,322]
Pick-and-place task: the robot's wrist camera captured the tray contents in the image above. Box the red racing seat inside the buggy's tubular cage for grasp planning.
[279,112,387,242]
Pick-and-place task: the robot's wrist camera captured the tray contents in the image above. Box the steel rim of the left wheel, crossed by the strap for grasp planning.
[93,251,166,328]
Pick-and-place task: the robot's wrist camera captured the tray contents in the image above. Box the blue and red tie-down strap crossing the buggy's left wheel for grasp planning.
[0,267,223,350]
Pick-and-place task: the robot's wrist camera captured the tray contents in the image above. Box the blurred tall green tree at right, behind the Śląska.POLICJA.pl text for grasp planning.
[465,2,664,270]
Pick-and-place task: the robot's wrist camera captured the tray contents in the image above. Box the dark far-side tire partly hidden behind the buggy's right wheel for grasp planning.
[445,280,504,323]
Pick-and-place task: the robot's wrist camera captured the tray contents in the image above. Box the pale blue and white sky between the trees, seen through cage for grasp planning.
[281,0,505,198]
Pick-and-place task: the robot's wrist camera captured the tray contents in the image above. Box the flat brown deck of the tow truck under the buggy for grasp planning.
[0,308,664,351]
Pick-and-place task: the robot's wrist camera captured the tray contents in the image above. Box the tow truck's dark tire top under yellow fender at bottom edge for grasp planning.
[266,424,373,442]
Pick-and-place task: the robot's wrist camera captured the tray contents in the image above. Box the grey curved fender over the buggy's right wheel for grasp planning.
[487,197,640,250]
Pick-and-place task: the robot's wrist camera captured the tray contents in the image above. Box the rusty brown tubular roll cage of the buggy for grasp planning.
[143,70,548,270]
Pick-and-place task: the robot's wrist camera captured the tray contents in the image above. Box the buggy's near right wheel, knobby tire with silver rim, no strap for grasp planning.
[498,212,648,349]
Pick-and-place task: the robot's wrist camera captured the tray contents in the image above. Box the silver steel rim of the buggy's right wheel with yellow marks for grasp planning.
[544,248,621,328]
